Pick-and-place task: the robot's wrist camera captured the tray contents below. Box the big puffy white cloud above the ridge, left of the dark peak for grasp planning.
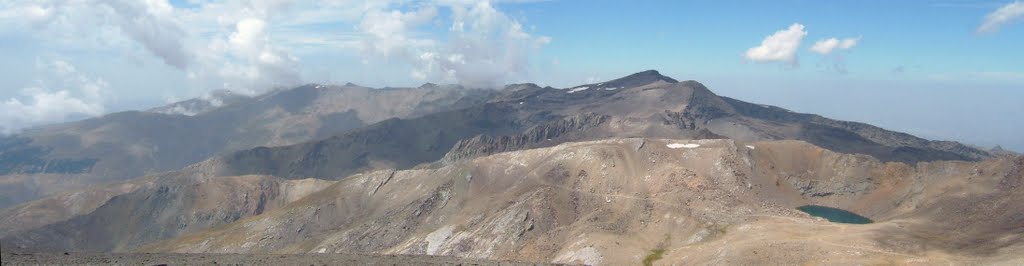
[360,1,551,87]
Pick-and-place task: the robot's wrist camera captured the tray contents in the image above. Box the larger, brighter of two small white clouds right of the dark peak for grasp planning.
[743,24,807,67]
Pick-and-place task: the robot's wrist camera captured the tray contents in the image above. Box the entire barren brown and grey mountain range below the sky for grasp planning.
[0,71,1024,265]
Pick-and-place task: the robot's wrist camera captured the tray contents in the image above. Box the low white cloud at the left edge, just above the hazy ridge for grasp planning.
[0,59,110,134]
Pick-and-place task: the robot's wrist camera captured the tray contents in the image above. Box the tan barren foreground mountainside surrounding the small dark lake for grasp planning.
[117,139,1024,265]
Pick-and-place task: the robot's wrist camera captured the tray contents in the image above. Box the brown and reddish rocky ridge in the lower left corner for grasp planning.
[0,176,332,252]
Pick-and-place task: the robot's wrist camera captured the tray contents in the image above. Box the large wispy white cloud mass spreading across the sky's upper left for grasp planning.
[0,0,299,92]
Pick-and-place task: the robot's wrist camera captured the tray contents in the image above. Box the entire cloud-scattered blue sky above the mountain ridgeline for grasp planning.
[0,0,1024,150]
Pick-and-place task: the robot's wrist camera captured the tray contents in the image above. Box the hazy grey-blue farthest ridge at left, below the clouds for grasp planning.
[0,84,493,208]
